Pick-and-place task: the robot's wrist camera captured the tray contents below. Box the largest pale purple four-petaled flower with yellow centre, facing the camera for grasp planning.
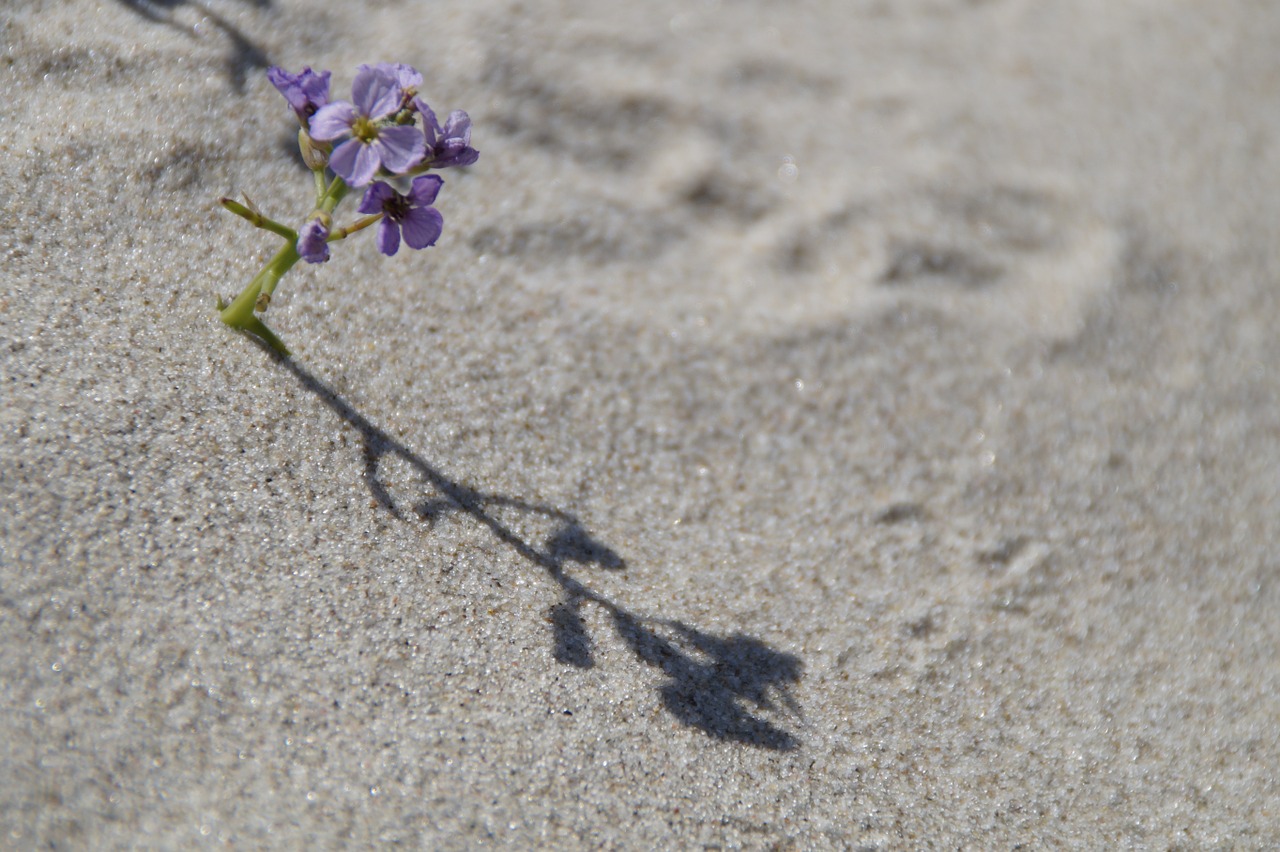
[311,63,425,187]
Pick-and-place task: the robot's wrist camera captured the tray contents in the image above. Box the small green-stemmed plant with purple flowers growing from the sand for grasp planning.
[218,63,480,354]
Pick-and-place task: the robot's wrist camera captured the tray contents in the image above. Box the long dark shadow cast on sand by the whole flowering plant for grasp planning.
[251,338,804,751]
